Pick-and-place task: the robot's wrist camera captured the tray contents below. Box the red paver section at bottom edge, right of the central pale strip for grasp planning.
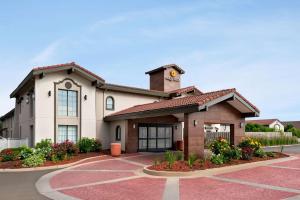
[179,177,295,200]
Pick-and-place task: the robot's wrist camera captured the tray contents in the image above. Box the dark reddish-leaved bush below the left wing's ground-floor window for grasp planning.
[51,140,79,162]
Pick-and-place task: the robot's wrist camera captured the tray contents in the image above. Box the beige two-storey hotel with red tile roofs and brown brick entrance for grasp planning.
[0,62,259,159]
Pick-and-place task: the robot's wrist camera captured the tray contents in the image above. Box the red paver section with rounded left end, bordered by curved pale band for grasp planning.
[50,171,135,189]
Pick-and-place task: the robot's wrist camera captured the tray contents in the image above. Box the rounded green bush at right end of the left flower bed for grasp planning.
[77,137,102,153]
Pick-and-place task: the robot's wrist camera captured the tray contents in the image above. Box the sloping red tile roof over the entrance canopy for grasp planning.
[110,88,251,116]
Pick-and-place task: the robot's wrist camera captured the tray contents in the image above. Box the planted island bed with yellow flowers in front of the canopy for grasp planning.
[148,138,288,172]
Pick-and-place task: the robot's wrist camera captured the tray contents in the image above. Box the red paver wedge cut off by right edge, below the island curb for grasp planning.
[217,166,300,190]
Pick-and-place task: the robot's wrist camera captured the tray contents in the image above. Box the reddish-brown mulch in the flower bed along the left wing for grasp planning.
[0,152,107,169]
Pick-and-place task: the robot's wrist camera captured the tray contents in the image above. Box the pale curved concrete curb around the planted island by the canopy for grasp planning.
[143,156,298,178]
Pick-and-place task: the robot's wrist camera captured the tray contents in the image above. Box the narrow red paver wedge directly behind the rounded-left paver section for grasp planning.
[73,159,142,170]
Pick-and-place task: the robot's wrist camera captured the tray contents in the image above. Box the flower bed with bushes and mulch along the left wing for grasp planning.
[0,138,101,169]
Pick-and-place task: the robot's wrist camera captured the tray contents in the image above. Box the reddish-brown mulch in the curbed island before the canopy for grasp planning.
[148,152,289,172]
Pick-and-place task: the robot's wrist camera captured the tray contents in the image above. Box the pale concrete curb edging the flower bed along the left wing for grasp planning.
[0,155,107,173]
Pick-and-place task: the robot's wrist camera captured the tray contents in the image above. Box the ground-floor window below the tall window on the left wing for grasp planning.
[56,125,77,143]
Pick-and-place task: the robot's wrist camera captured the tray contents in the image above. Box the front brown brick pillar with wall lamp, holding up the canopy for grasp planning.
[184,113,204,160]
